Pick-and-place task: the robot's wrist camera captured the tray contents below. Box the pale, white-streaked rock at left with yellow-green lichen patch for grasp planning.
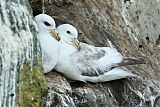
[0,0,47,107]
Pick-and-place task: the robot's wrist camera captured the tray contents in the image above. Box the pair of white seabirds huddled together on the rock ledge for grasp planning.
[35,14,144,82]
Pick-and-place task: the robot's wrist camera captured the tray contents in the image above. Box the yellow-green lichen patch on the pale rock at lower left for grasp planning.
[18,63,48,107]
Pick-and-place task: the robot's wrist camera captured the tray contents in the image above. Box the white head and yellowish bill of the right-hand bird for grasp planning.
[56,24,81,50]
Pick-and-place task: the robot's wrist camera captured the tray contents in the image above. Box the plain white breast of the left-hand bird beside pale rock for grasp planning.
[39,32,60,73]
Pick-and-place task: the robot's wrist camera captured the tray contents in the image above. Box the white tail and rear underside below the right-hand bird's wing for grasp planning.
[83,67,137,82]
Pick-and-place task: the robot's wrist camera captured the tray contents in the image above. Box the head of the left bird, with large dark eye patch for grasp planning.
[34,14,60,41]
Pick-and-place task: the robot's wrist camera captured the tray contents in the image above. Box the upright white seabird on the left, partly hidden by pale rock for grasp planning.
[35,14,60,73]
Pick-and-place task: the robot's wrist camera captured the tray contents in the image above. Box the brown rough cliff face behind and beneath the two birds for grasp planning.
[30,0,160,107]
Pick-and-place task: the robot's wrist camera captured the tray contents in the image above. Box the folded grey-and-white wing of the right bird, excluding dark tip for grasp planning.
[73,43,121,76]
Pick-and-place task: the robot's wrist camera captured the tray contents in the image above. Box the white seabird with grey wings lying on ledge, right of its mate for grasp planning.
[54,24,143,82]
